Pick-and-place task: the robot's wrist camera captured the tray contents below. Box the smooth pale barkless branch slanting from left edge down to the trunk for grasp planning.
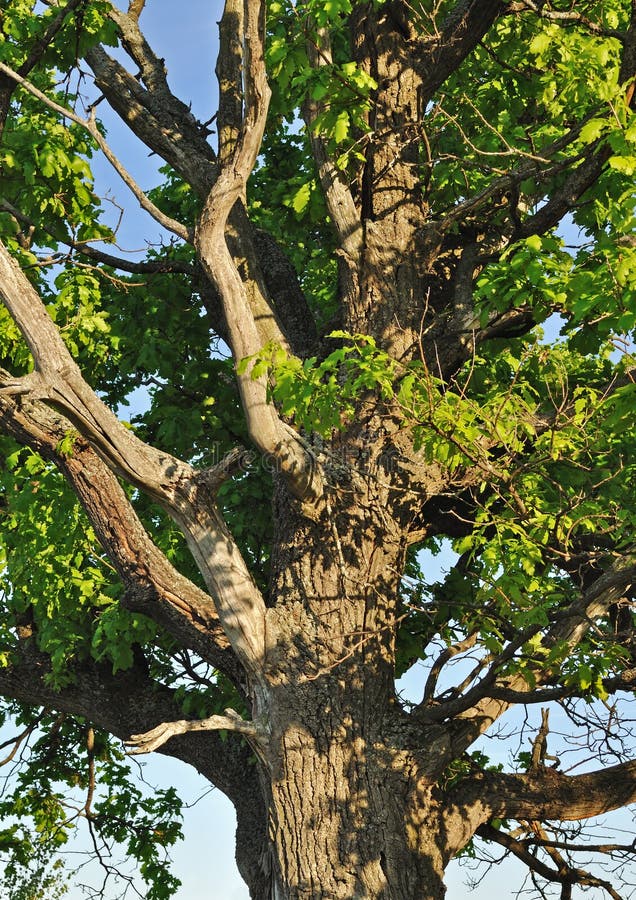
[0,244,265,681]
